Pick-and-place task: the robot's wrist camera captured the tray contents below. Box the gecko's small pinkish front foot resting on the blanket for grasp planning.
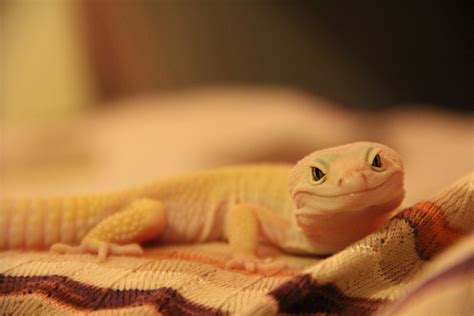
[225,255,288,273]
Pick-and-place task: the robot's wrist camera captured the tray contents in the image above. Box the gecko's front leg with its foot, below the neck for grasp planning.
[226,204,287,272]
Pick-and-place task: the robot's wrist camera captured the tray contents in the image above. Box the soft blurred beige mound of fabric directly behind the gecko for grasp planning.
[1,87,474,205]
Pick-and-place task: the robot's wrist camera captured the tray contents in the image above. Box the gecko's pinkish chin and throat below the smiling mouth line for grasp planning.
[293,175,405,253]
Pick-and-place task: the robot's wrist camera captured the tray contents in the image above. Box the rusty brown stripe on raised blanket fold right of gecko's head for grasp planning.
[395,202,466,261]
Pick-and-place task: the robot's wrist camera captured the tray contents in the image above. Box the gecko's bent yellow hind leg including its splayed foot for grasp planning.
[50,198,167,261]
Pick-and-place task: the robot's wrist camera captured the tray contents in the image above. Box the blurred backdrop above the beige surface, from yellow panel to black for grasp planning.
[2,0,474,115]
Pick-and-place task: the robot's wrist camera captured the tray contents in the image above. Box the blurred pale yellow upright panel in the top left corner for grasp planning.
[2,0,95,118]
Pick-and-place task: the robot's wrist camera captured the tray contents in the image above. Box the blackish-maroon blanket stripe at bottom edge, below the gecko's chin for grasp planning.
[269,274,387,315]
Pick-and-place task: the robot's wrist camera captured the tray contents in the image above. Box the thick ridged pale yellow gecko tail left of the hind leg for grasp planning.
[0,194,130,250]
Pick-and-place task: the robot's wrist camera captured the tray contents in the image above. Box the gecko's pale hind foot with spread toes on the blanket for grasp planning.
[49,242,143,262]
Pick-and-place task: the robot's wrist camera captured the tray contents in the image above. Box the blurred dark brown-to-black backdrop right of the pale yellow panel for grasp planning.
[84,0,474,110]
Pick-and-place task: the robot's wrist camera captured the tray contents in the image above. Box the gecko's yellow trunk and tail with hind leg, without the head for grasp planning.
[0,164,293,254]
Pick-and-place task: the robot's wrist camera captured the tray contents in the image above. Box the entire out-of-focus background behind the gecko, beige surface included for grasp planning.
[0,0,474,204]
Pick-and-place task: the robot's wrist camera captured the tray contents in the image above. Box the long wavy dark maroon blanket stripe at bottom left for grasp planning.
[0,274,225,315]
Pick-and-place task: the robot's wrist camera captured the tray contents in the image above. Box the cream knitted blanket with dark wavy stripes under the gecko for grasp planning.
[0,174,474,315]
